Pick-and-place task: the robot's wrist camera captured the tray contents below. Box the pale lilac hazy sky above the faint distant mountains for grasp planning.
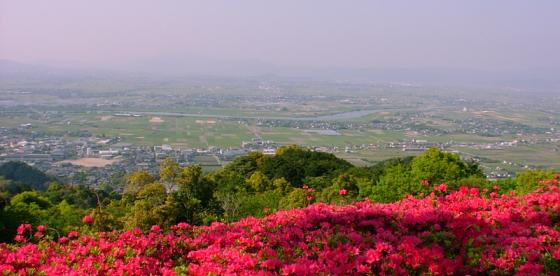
[0,0,560,73]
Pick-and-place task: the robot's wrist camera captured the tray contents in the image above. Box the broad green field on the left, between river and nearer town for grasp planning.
[2,114,253,148]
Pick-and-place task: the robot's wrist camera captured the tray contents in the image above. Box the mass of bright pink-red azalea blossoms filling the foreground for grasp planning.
[0,180,560,275]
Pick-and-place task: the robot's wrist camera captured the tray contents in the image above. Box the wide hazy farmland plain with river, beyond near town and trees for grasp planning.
[0,77,560,175]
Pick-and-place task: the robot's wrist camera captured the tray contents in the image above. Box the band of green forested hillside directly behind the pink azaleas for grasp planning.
[0,146,554,241]
